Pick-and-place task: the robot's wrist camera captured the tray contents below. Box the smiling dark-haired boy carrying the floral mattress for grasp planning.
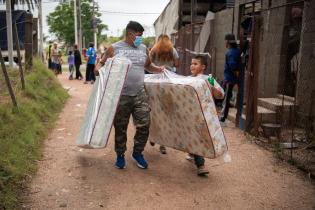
[186,55,224,176]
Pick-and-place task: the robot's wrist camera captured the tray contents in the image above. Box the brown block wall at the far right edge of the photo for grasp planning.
[296,0,315,128]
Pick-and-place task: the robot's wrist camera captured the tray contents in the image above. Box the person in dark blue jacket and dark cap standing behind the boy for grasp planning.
[220,34,241,122]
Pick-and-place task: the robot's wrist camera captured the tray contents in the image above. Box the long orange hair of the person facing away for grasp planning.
[150,34,174,62]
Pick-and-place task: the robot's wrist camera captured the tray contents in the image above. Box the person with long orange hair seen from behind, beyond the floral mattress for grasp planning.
[150,34,179,154]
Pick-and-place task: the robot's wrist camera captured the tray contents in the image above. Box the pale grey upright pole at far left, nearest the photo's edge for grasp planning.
[5,0,13,68]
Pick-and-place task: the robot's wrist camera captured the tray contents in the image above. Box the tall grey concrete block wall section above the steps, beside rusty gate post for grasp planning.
[258,0,286,97]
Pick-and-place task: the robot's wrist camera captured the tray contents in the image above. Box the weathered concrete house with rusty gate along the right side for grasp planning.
[155,0,315,135]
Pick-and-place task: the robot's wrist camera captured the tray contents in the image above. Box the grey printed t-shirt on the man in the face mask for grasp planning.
[112,41,148,96]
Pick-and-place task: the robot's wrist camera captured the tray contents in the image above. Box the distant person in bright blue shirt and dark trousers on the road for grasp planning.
[84,42,96,84]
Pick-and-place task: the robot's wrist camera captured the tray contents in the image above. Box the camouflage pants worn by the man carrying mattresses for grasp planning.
[114,88,150,155]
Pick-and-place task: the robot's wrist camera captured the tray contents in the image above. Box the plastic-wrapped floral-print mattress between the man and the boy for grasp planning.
[145,72,228,158]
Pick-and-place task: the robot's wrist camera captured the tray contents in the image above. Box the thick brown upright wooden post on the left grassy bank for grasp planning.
[24,14,33,70]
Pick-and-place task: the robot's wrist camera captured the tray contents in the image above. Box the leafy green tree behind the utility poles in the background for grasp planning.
[47,0,107,44]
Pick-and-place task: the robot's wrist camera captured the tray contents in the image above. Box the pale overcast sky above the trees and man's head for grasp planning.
[0,0,169,36]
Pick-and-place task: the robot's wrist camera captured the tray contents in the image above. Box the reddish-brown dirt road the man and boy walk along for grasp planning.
[23,74,315,210]
